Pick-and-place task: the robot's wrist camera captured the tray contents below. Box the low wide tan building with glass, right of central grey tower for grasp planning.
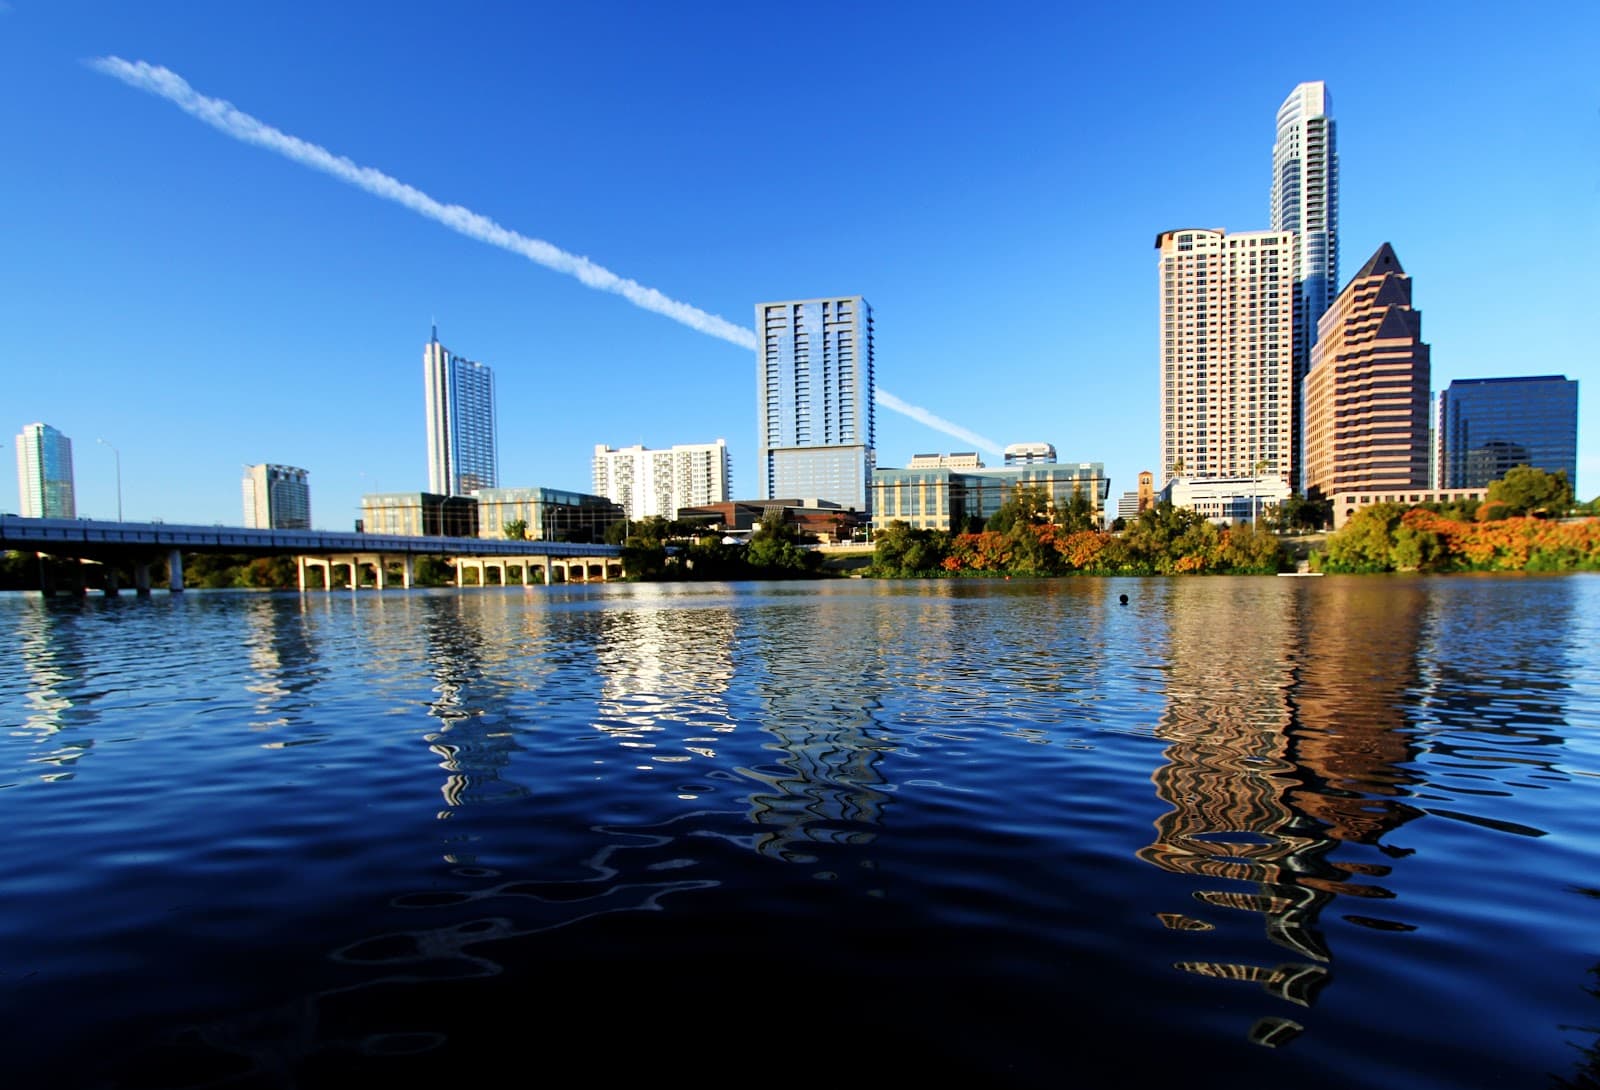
[872,463,1110,533]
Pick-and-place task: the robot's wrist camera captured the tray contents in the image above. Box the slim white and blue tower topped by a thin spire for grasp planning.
[422,325,499,496]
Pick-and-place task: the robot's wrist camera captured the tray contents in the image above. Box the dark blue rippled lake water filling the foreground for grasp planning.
[0,575,1600,1090]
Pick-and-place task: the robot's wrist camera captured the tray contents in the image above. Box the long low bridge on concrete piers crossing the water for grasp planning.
[0,515,622,594]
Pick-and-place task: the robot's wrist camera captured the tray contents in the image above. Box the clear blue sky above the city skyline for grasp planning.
[0,0,1600,528]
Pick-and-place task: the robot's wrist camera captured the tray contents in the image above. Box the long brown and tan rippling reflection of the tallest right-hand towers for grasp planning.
[1139,583,1422,1045]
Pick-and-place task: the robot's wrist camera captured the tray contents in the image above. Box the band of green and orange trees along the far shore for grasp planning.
[0,467,1600,591]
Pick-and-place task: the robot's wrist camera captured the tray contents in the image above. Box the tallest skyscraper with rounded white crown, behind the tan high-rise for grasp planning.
[1267,80,1339,488]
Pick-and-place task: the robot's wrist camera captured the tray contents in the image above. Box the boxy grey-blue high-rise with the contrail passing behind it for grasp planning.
[755,295,877,512]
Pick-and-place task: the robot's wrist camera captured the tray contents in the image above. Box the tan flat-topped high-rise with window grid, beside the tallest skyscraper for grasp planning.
[1155,229,1296,482]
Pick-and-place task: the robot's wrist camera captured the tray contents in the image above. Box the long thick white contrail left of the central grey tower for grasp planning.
[88,56,755,349]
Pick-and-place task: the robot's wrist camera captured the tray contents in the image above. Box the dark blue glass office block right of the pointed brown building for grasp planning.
[1434,375,1578,495]
